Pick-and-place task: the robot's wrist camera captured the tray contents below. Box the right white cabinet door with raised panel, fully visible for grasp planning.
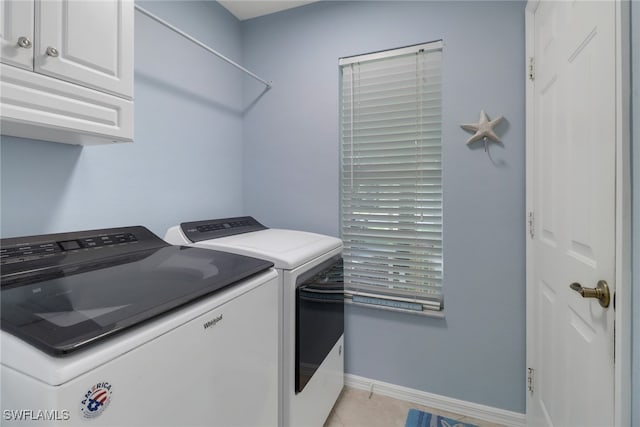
[34,0,134,99]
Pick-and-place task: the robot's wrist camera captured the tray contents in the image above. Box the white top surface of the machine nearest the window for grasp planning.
[196,228,342,270]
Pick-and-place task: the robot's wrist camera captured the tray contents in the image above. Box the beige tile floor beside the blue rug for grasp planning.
[324,387,502,427]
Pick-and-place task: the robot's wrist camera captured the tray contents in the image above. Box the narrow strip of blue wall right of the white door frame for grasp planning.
[631,1,640,426]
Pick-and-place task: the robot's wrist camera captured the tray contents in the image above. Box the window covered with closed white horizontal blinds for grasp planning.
[339,41,443,313]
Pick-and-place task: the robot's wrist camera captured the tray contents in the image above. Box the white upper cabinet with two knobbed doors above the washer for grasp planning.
[0,0,134,144]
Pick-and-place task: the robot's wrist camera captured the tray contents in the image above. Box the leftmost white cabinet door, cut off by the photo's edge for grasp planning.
[0,0,33,70]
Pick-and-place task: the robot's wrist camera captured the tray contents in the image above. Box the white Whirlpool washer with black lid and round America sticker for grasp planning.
[0,227,280,427]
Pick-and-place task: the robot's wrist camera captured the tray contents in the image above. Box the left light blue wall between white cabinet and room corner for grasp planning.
[0,1,243,237]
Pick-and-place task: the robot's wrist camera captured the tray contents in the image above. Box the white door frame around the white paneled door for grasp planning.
[523,0,632,426]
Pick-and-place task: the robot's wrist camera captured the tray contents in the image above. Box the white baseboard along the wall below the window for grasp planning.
[344,374,526,427]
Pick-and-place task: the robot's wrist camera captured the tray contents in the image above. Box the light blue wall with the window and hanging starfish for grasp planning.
[242,1,525,413]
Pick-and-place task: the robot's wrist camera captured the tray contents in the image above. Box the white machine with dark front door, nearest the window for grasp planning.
[165,217,344,427]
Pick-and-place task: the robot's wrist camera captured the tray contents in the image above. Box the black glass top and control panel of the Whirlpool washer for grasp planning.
[0,227,273,356]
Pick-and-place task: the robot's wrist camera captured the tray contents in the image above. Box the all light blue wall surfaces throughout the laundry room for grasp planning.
[0,1,640,425]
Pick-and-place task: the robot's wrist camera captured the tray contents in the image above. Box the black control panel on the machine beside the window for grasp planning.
[180,216,267,243]
